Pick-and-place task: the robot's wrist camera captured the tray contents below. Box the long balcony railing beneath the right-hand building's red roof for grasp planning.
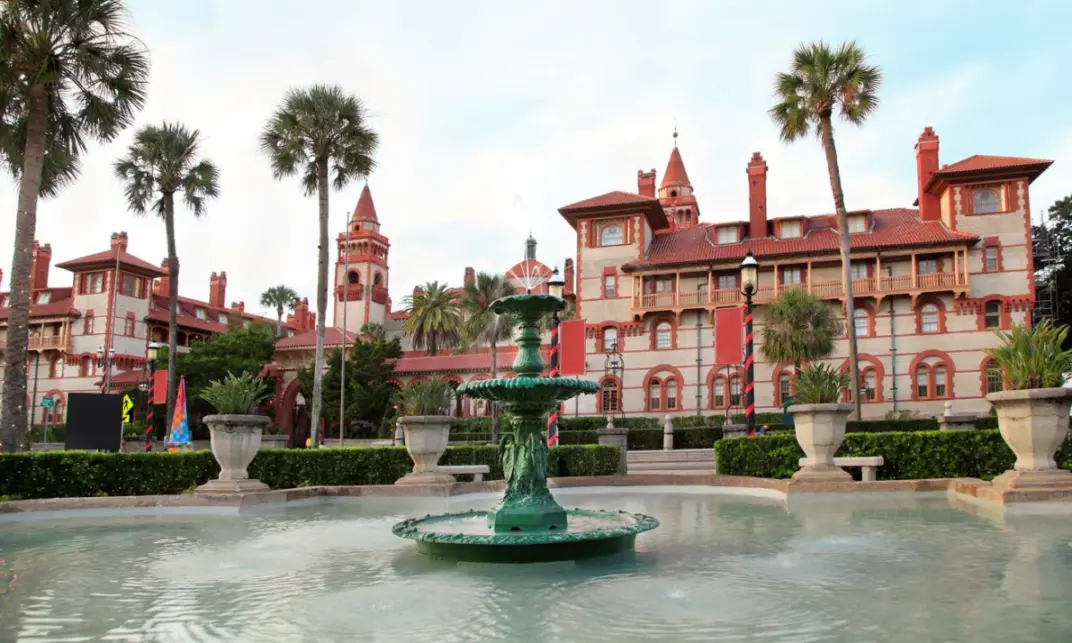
[632,272,968,310]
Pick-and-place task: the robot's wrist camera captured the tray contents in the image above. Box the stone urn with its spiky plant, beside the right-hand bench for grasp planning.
[789,364,853,481]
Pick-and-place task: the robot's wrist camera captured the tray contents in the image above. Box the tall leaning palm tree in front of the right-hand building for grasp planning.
[770,42,882,420]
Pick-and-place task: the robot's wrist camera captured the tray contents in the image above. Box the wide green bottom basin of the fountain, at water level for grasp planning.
[392,509,659,563]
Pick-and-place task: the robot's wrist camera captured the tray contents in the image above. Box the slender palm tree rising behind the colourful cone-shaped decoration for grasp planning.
[115,122,220,428]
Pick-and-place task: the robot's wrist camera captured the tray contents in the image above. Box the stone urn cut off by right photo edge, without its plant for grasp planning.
[986,388,1072,489]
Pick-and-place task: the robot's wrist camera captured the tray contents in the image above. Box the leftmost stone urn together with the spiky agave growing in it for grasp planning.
[197,373,269,493]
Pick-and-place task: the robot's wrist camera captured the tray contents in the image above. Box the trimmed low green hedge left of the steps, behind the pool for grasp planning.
[0,445,619,499]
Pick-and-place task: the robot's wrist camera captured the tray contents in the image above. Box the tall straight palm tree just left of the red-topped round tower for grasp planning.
[260,85,379,445]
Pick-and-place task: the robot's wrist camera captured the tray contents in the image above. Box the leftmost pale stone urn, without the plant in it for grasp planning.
[197,415,269,493]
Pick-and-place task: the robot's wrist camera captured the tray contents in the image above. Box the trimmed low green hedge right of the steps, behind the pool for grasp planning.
[715,430,1072,480]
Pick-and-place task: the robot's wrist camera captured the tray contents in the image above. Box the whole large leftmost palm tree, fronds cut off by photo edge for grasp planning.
[0,0,149,450]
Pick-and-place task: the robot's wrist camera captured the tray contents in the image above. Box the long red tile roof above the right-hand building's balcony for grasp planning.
[622,208,979,271]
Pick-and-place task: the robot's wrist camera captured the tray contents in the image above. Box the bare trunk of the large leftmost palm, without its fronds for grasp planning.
[0,84,48,451]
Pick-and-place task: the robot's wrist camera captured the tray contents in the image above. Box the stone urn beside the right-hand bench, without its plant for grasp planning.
[789,404,854,482]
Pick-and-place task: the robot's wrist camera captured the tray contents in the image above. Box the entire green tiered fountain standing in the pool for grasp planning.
[393,295,659,563]
